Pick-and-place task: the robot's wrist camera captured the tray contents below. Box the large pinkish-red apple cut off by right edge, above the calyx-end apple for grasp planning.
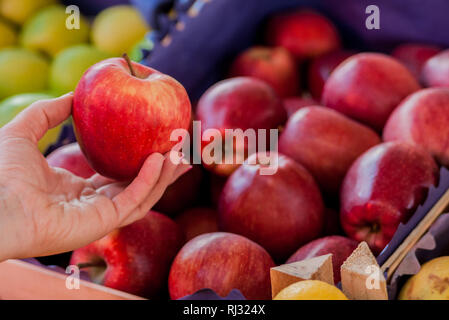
[383,88,449,166]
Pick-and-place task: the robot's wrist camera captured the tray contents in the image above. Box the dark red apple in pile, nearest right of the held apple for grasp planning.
[197,77,287,176]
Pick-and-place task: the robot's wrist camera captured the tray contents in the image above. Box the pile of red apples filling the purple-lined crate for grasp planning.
[44,10,449,299]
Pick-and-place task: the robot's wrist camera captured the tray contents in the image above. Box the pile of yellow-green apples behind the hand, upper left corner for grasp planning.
[0,0,149,152]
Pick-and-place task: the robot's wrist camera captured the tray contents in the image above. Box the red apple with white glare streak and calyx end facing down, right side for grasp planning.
[340,142,438,254]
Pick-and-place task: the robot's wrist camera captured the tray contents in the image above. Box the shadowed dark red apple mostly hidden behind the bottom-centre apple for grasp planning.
[175,208,218,241]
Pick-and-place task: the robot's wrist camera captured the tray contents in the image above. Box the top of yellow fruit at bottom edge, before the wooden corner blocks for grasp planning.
[274,280,348,300]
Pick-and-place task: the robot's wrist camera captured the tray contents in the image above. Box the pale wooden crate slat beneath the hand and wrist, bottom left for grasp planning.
[0,260,143,300]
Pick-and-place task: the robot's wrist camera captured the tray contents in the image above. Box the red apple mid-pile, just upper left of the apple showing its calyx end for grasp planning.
[279,106,380,196]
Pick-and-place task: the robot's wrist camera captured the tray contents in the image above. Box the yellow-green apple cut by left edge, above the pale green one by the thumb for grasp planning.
[0,48,50,99]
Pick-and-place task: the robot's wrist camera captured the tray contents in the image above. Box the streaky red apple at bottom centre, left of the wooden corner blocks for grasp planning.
[168,232,275,300]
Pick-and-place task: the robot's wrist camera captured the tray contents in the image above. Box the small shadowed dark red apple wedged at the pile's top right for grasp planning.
[391,43,441,80]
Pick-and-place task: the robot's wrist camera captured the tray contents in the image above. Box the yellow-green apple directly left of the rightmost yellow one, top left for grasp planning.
[20,5,89,57]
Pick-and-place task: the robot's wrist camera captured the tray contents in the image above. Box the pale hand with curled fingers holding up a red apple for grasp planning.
[0,94,191,261]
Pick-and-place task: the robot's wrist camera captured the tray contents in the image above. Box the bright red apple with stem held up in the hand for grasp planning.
[72,58,191,180]
